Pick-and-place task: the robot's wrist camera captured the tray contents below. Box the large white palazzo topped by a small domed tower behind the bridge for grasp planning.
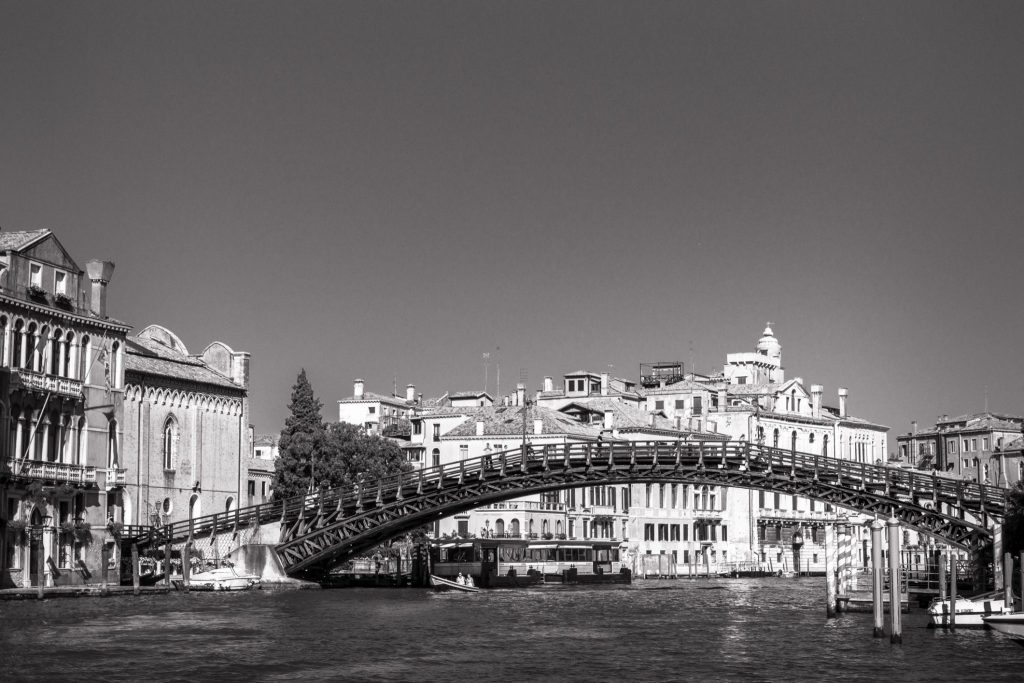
[642,326,888,571]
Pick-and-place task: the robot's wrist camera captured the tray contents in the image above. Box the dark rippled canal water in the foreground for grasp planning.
[0,579,1024,683]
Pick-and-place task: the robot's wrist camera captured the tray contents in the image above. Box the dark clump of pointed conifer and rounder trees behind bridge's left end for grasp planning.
[273,370,411,499]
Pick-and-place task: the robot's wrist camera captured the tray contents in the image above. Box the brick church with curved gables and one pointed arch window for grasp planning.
[119,325,253,524]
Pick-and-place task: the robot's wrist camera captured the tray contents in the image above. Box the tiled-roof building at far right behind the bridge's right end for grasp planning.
[896,412,1024,486]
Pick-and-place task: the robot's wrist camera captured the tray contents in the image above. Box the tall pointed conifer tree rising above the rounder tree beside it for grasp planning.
[273,369,325,499]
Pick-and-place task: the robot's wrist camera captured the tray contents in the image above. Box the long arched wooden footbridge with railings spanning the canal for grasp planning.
[136,441,1006,574]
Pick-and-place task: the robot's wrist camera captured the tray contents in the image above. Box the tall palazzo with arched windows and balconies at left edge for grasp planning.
[0,229,131,588]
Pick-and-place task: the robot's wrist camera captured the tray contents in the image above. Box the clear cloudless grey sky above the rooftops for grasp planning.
[0,0,1024,450]
